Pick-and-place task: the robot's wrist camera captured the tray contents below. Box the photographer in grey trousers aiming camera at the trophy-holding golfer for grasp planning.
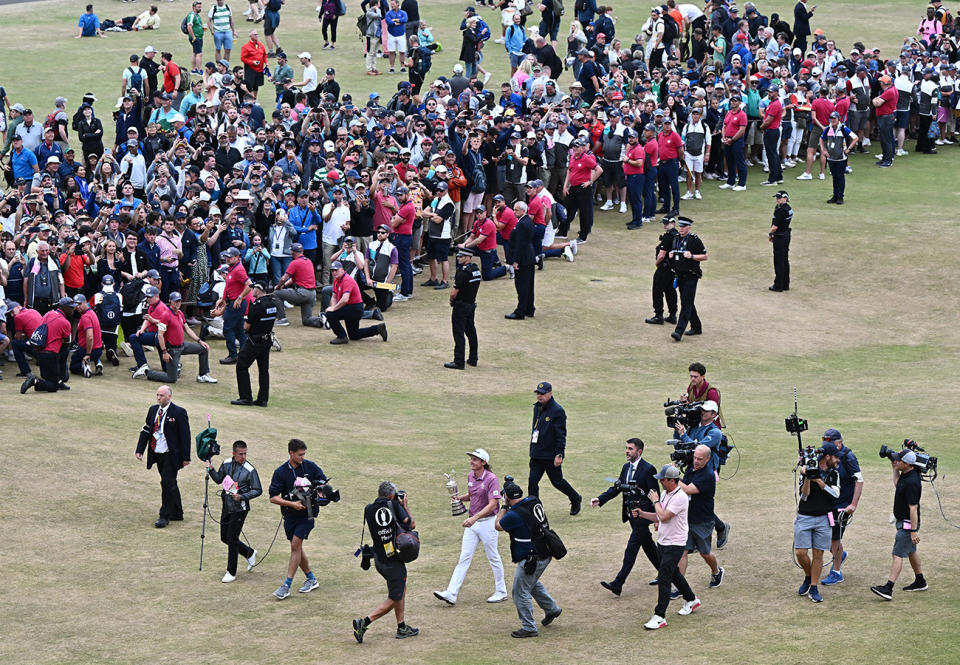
[496,477,563,638]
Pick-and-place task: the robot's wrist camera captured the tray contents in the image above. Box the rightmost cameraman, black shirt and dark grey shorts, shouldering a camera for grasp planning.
[870,450,928,600]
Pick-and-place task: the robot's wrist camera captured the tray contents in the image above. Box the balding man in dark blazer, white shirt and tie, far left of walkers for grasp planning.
[135,386,190,529]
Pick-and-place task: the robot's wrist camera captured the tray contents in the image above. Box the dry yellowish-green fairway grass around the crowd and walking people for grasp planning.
[0,0,960,665]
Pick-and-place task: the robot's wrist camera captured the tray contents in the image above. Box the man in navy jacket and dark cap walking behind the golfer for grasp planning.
[527,381,583,515]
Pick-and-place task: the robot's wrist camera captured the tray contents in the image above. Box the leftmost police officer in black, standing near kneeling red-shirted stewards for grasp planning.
[230,283,278,407]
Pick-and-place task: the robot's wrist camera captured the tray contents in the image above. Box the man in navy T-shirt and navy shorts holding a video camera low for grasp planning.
[269,439,327,600]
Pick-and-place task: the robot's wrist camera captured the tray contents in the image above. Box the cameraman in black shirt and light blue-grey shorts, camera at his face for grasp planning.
[793,441,840,603]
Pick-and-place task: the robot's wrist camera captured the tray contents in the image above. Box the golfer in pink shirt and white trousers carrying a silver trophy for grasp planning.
[433,448,507,605]
